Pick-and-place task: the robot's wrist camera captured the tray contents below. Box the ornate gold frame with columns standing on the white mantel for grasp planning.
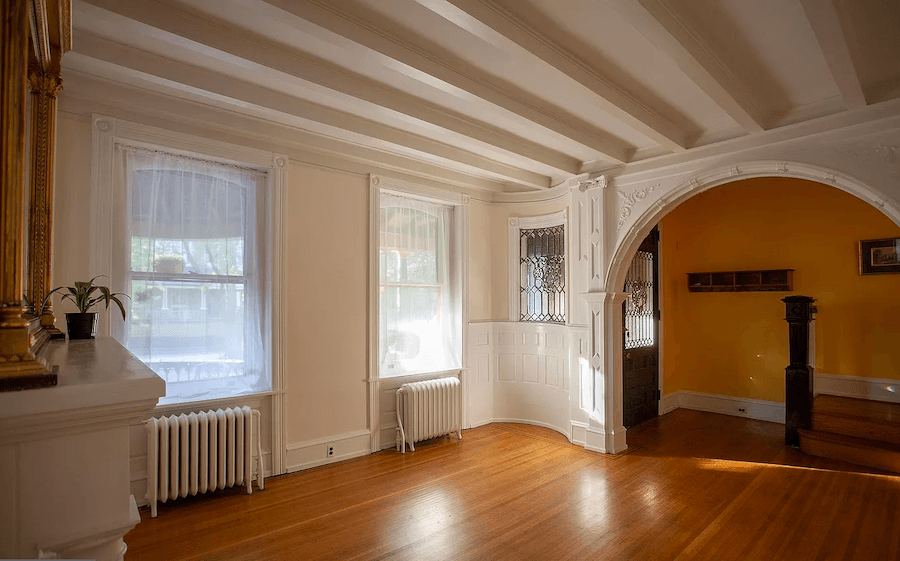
[0,0,72,391]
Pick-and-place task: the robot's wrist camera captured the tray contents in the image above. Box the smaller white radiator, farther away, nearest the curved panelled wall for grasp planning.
[397,378,462,453]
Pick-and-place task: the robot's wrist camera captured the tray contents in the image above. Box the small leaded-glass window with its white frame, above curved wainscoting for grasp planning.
[509,211,567,324]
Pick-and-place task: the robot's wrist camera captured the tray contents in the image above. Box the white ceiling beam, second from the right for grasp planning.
[608,0,765,133]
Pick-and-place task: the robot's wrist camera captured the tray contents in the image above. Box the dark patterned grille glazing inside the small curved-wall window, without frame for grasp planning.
[519,224,566,323]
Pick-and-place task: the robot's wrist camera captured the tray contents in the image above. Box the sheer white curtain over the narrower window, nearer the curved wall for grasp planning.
[379,192,462,377]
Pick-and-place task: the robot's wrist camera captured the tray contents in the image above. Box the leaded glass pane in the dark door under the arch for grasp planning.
[625,251,656,349]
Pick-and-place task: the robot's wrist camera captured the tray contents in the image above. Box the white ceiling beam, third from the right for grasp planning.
[447,0,687,152]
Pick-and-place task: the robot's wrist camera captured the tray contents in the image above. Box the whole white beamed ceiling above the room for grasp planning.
[63,0,900,191]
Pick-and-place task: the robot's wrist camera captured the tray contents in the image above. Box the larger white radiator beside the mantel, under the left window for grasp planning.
[144,405,265,518]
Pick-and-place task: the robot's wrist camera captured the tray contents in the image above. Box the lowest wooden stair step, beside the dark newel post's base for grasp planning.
[797,429,900,473]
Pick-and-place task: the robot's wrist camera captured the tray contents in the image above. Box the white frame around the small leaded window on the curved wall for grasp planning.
[508,208,572,325]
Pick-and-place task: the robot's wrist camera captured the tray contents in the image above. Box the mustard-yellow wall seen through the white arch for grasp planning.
[660,178,900,401]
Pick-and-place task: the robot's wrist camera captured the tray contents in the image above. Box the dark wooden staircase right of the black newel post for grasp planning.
[797,395,900,473]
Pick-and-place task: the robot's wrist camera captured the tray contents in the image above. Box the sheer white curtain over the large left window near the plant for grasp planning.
[113,145,271,404]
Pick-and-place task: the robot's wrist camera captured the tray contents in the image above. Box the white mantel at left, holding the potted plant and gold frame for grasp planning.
[0,337,165,561]
